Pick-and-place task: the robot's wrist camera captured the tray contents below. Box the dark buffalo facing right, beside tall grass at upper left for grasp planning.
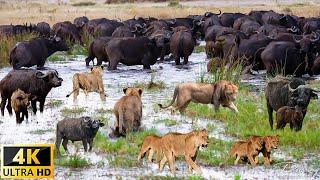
[10,37,69,69]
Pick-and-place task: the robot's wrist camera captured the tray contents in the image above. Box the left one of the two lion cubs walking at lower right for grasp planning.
[229,136,263,166]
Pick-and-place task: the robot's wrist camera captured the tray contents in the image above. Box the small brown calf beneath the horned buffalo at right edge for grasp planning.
[277,106,307,131]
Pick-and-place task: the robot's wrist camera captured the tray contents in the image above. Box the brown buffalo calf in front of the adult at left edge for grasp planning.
[11,89,30,124]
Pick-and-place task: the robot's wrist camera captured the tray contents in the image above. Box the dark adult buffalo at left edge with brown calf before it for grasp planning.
[0,69,63,116]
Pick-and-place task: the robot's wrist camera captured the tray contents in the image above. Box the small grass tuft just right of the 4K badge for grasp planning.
[54,155,90,168]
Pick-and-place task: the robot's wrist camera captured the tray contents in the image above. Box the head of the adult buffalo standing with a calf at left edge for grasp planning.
[36,70,63,87]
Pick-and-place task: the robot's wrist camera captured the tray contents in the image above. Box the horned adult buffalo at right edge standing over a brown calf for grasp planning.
[265,76,318,129]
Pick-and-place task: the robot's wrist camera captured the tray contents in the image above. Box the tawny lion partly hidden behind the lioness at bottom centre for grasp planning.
[138,135,162,163]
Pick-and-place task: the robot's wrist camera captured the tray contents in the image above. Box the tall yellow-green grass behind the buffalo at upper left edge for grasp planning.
[0,33,37,68]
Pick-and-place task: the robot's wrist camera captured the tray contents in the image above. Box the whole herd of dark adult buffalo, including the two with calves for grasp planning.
[0,10,320,127]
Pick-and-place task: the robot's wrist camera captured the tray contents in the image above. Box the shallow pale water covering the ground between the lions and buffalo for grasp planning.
[0,50,320,179]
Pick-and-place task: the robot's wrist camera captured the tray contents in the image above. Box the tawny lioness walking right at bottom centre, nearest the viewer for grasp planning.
[159,129,209,173]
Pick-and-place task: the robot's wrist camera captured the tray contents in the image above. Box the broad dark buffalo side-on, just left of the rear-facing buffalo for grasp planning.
[106,37,160,70]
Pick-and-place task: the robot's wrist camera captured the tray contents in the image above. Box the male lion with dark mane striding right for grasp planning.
[158,80,238,114]
